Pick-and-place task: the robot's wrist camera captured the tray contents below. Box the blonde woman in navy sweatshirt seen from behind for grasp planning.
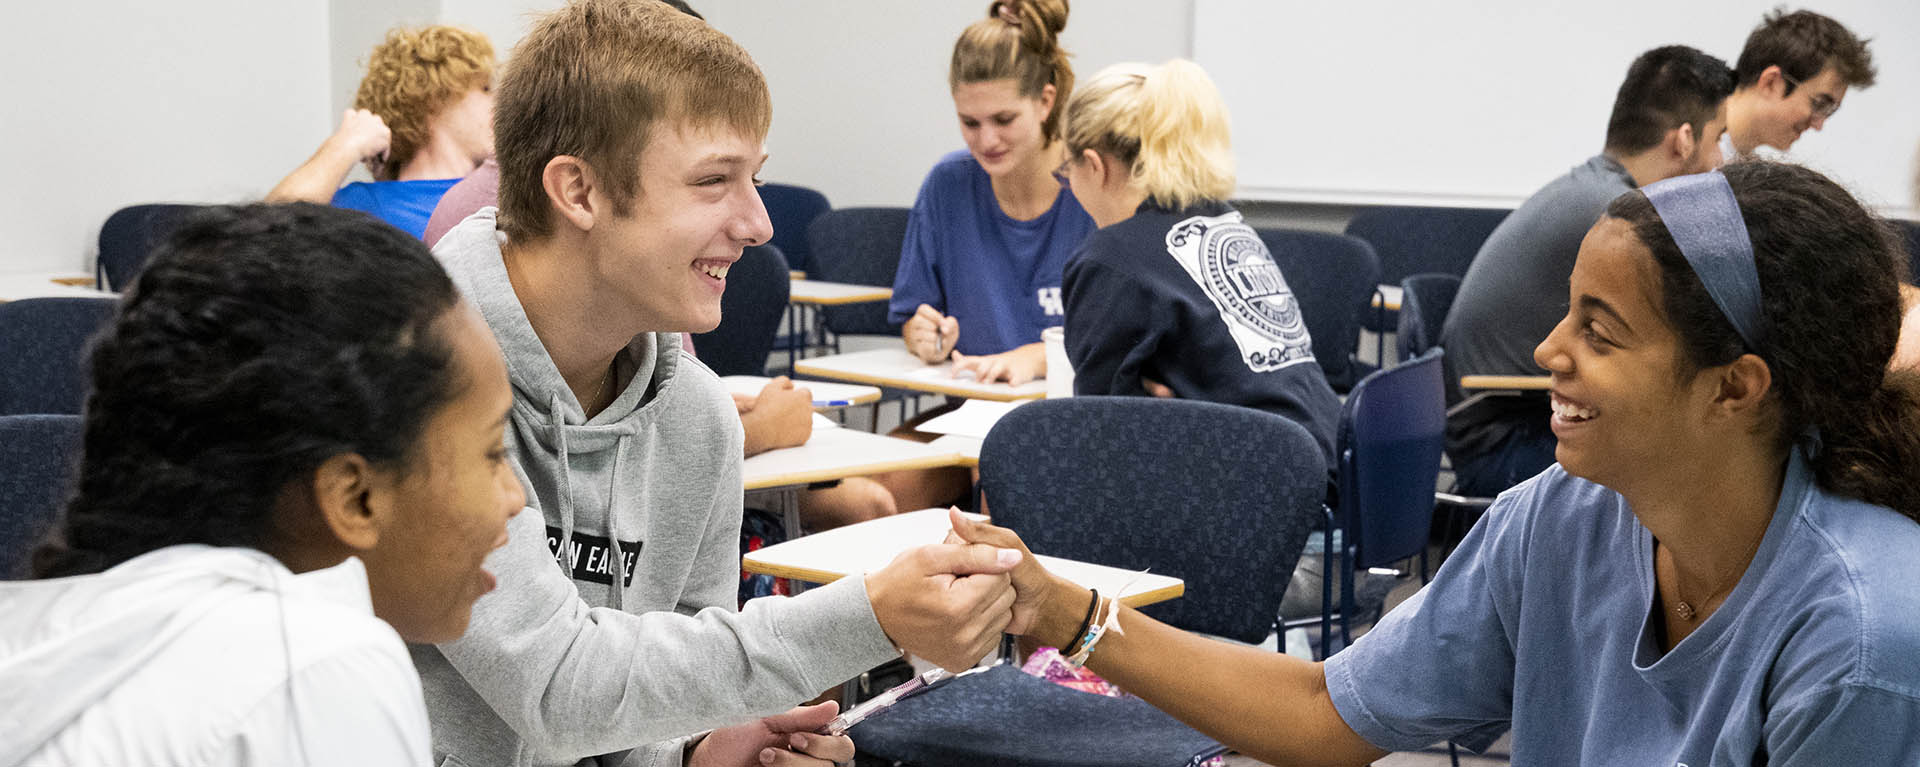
[1062,60,1340,461]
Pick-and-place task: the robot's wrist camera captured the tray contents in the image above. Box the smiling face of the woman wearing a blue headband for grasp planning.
[1534,217,1713,490]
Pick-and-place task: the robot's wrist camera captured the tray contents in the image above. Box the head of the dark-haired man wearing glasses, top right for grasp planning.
[1722,10,1874,160]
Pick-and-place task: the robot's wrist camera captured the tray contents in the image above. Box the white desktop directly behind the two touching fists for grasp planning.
[741,509,1187,607]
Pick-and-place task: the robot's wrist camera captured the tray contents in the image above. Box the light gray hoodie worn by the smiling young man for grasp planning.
[413,208,897,767]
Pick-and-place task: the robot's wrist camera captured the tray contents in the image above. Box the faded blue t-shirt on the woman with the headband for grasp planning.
[1327,452,1920,767]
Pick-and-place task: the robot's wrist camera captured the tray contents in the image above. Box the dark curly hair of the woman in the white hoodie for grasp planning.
[35,204,467,577]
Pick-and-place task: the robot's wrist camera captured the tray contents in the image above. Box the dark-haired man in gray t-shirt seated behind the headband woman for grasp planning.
[1440,46,1734,496]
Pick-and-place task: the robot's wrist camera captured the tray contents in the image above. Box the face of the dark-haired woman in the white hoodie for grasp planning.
[361,302,526,642]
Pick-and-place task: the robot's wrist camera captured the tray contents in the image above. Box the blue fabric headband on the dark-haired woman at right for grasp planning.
[1645,171,1764,352]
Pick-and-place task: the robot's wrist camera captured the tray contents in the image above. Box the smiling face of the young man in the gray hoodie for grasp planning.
[588,123,774,333]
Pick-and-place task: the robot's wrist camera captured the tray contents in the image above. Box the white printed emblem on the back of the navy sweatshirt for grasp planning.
[1167,211,1313,373]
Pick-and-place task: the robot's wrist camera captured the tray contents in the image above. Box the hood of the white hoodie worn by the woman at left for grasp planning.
[0,544,372,765]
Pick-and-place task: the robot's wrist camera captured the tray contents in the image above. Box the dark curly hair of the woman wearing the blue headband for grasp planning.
[1607,161,1920,521]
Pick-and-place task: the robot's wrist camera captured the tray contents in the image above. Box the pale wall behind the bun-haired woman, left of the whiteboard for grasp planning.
[442,0,1192,208]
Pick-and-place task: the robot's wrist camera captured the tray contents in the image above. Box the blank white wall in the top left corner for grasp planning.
[0,0,338,271]
